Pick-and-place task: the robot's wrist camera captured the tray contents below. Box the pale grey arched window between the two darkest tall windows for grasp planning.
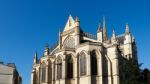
[80,52,86,76]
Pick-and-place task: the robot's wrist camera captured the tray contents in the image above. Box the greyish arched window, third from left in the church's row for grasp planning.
[56,57,62,79]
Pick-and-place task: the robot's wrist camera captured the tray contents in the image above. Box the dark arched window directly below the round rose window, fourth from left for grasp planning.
[67,55,73,78]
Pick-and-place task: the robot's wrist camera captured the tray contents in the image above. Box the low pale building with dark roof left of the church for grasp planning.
[0,62,22,84]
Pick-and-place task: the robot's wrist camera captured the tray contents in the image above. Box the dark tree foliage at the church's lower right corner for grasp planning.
[120,60,150,84]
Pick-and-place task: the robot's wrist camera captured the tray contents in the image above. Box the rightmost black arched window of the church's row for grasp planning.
[91,50,97,75]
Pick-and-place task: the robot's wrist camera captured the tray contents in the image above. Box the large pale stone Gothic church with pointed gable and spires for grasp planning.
[31,15,137,84]
